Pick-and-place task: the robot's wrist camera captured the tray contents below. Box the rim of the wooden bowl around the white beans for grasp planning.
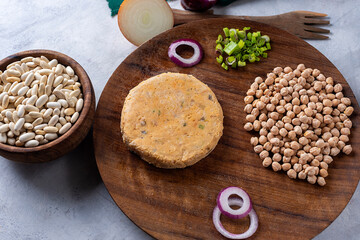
[0,49,94,153]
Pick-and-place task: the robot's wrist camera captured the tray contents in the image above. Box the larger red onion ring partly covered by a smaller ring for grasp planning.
[213,198,259,239]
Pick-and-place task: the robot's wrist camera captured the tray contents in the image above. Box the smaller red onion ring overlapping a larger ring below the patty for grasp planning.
[216,187,252,219]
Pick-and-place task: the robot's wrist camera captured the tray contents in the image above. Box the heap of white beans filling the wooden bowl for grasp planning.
[0,56,84,147]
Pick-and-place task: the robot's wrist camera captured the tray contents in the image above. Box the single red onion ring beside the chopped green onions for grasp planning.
[168,39,204,67]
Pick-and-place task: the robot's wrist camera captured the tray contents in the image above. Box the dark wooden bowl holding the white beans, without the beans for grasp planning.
[0,50,95,163]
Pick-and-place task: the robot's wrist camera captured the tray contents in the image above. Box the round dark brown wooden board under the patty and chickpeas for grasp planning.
[94,19,360,239]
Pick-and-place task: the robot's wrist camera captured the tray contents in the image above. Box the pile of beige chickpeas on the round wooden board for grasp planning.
[244,64,354,186]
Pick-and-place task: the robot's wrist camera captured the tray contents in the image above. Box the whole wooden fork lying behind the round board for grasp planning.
[173,9,330,39]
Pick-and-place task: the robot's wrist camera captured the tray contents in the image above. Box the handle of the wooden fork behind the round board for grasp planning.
[173,9,282,26]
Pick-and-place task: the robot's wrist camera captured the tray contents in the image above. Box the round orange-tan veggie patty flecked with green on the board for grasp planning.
[121,73,224,168]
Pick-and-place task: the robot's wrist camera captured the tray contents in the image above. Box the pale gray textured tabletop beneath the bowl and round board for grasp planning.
[0,0,360,240]
